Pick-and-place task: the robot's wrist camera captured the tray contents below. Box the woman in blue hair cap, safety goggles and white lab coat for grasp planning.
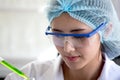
[5,0,120,80]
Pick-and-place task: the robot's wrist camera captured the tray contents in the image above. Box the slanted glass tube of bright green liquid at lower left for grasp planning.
[0,57,29,80]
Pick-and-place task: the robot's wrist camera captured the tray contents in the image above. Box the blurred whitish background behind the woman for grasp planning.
[0,0,120,80]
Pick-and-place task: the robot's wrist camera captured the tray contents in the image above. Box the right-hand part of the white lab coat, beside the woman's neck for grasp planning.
[99,56,120,80]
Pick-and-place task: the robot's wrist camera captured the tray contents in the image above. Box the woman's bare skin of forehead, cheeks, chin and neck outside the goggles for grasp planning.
[51,13,103,80]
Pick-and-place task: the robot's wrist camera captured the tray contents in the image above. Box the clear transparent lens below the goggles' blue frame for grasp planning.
[49,35,91,47]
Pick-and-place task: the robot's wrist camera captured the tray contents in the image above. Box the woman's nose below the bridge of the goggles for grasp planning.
[64,41,75,53]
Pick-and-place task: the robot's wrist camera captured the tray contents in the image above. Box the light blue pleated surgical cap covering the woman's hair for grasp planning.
[47,0,120,59]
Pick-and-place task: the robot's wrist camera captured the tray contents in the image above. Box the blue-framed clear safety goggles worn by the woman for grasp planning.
[45,22,107,47]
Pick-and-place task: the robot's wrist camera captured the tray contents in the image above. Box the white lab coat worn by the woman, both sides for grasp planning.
[5,55,120,80]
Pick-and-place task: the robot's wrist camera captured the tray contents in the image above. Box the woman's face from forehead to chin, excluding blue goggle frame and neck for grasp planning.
[51,13,100,70]
